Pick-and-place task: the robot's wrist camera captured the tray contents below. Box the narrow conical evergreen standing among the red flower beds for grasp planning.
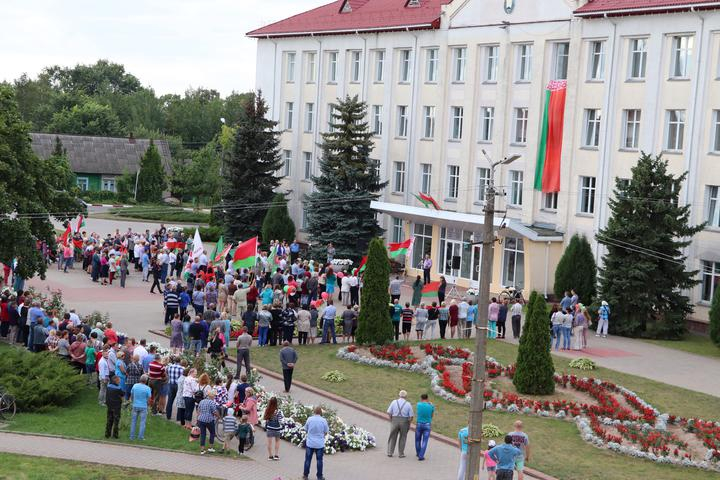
[513,291,555,395]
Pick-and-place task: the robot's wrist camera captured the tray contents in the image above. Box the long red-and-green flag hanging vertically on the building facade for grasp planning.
[535,80,567,193]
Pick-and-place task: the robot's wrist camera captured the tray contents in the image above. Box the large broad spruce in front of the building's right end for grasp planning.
[597,153,704,339]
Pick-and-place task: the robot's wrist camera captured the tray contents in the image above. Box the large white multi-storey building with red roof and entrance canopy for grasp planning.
[248,0,720,321]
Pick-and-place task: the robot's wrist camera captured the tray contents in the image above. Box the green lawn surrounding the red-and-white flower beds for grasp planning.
[251,340,720,480]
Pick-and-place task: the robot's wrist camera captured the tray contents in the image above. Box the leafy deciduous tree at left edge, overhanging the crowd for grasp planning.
[0,84,84,278]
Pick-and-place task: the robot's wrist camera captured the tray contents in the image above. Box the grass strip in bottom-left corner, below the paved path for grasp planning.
[0,453,207,480]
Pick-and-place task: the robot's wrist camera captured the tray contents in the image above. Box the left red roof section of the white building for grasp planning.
[247,0,452,37]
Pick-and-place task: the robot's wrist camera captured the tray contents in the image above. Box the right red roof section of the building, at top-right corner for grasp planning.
[574,0,720,17]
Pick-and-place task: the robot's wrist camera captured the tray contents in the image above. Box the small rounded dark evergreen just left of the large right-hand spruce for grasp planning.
[554,234,597,305]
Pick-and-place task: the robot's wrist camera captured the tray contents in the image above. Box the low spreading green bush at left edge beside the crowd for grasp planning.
[0,348,85,412]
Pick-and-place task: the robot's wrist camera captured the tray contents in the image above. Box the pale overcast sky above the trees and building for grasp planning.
[0,0,320,96]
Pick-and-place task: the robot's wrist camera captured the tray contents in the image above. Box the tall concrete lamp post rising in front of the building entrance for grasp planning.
[465,150,520,480]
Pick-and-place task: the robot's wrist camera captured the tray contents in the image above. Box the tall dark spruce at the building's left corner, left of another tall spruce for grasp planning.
[217,92,282,242]
